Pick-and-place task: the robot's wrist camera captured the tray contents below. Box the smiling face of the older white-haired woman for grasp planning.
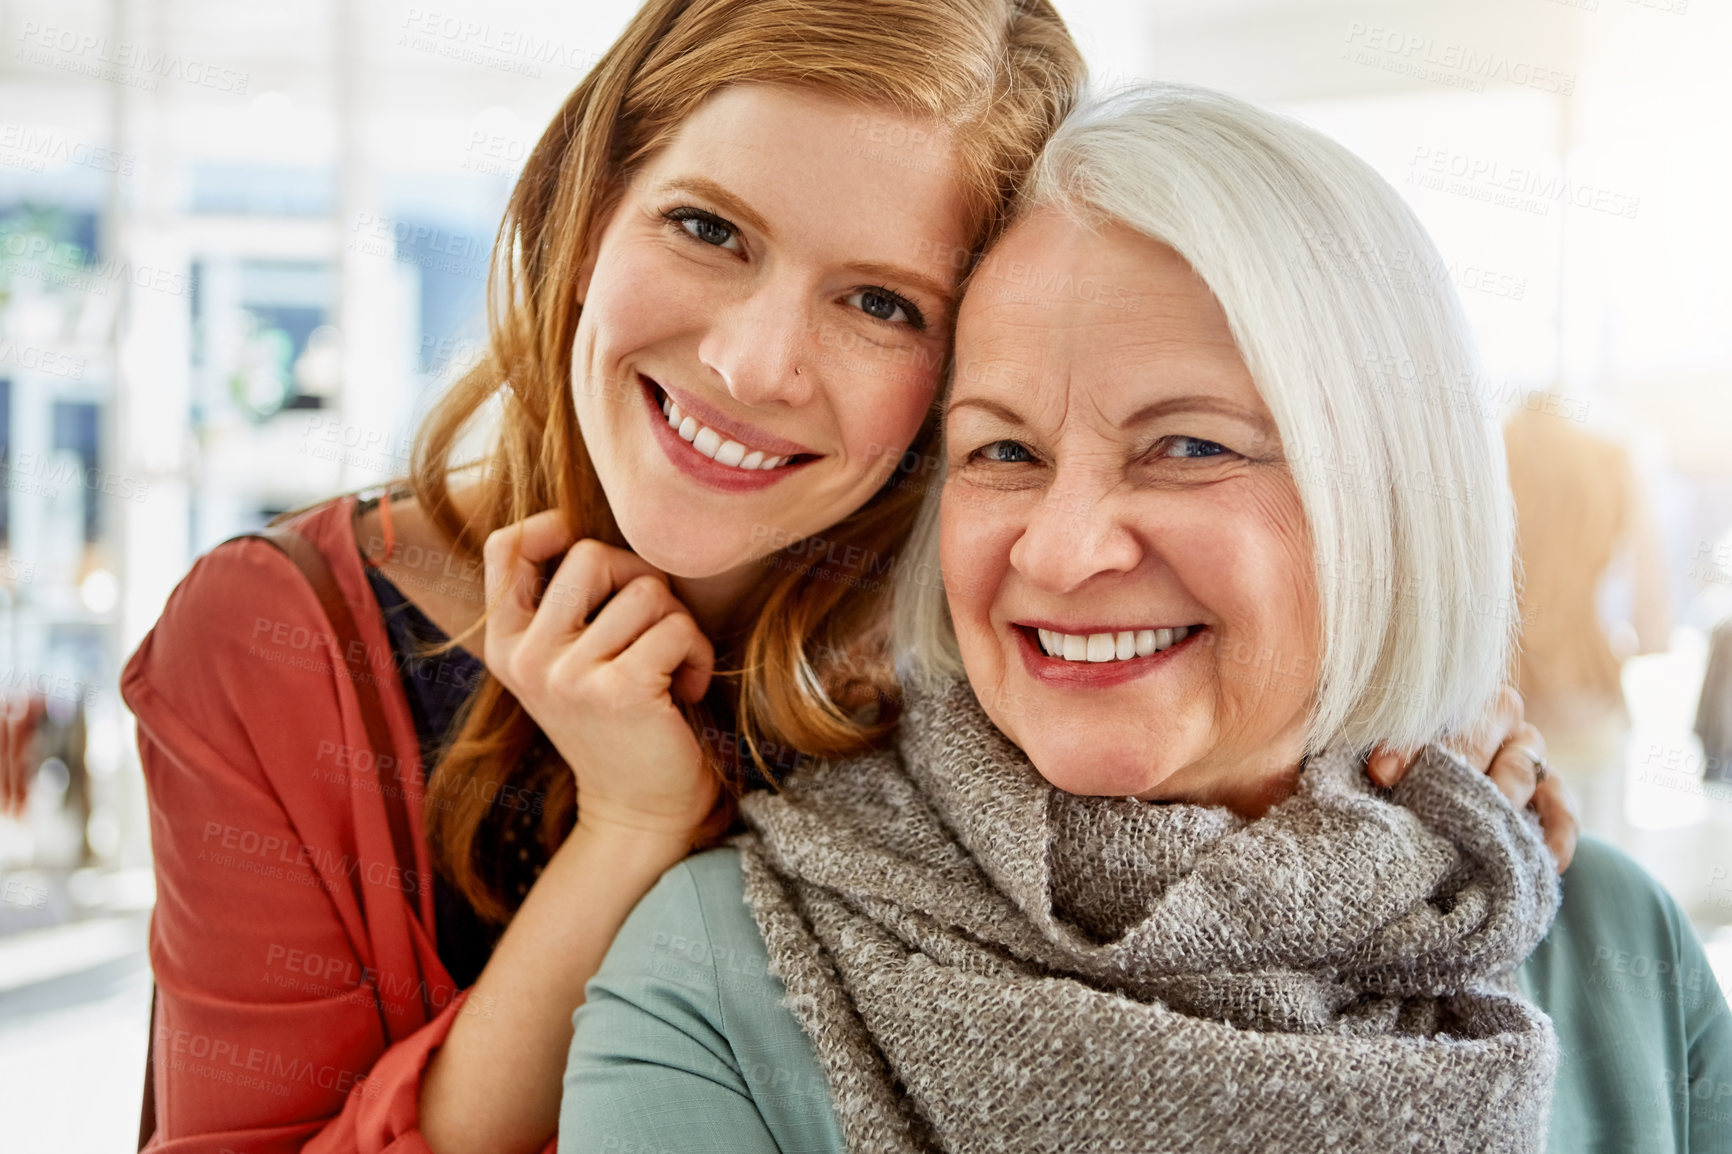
[942,211,1320,813]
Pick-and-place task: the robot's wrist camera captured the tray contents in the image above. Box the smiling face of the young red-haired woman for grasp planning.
[572,85,968,582]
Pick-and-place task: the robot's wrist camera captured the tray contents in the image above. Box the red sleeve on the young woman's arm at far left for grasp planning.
[121,541,512,1154]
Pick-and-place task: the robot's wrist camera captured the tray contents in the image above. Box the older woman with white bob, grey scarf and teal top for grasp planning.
[559,87,1732,1154]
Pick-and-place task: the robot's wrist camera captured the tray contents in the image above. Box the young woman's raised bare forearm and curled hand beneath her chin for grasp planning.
[419,509,721,1154]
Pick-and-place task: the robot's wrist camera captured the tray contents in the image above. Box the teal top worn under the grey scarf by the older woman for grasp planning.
[559,837,1732,1154]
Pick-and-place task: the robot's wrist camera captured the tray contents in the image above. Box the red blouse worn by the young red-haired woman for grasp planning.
[120,496,556,1154]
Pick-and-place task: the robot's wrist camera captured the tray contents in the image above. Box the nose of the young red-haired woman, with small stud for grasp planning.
[698,281,818,405]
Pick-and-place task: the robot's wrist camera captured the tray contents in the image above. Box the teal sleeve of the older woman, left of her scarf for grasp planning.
[559,863,779,1154]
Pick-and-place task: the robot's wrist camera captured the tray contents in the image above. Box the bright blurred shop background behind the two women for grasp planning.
[0,0,1732,1152]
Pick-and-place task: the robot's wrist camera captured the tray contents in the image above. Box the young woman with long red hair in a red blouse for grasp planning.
[123,0,1567,1154]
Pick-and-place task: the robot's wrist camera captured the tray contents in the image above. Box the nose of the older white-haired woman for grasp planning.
[1010,471,1143,593]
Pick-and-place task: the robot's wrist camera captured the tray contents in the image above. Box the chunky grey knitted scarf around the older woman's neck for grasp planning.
[736,684,1557,1154]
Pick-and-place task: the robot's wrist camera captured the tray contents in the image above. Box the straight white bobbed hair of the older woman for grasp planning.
[895,83,1516,750]
